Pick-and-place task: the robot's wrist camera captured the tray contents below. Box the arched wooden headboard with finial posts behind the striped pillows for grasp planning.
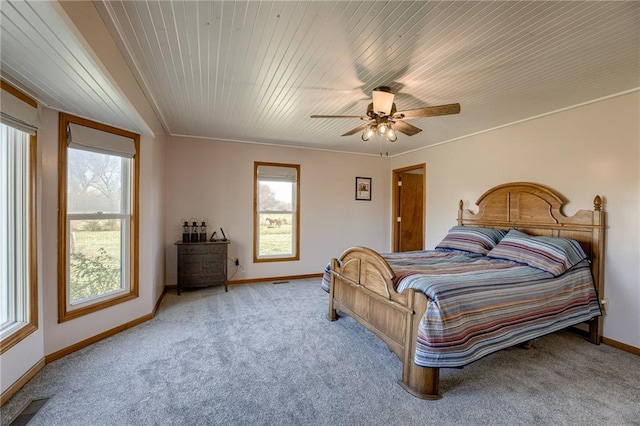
[458,182,605,342]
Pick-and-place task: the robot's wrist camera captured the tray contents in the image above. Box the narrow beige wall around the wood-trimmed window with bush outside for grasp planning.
[38,110,164,355]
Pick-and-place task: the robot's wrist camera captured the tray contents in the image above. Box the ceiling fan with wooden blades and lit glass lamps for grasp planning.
[311,86,460,142]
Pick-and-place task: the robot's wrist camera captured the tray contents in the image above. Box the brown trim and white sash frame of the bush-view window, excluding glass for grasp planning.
[58,114,140,322]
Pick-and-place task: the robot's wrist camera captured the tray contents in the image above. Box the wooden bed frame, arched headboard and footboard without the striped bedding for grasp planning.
[328,182,605,399]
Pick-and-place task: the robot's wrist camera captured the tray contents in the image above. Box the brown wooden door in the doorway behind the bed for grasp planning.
[394,166,425,251]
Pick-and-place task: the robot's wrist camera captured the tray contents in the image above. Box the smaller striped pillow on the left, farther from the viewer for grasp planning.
[436,226,507,254]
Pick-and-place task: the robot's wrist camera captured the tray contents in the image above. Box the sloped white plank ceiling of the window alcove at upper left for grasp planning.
[0,0,151,134]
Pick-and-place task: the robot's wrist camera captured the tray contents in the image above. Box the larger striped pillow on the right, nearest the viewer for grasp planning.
[487,229,587,277]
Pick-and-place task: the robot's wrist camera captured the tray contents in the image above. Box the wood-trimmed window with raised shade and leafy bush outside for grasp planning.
[58,114,140,322]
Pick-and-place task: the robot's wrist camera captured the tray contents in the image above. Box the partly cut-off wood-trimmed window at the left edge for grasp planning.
[0,82,39,354]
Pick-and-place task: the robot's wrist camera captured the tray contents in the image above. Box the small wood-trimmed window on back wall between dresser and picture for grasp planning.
[253,162,300,262]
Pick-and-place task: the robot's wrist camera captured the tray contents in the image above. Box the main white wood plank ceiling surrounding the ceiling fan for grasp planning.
[2,0,640,155]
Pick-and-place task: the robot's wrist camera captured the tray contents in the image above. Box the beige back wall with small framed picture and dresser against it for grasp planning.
[166,137,391,285]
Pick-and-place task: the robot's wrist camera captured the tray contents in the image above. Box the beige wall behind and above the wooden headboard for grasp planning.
[391,91,640,347]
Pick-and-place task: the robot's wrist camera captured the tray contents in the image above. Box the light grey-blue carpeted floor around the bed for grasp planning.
[1,279,640,426]
